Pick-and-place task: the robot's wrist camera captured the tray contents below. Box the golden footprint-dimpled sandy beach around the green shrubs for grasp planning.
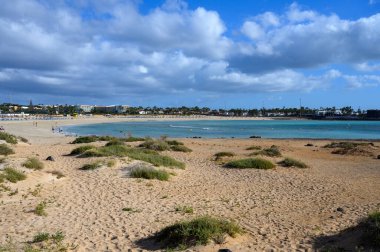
[0,117,380,251]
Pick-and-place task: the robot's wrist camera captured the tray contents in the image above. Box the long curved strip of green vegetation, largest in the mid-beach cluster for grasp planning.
[79,145,185,169]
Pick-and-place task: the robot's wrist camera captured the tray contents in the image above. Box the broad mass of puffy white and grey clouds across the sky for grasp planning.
[0,0,380,103]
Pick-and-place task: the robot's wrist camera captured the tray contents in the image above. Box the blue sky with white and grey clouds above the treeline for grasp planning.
[0,0,380,108]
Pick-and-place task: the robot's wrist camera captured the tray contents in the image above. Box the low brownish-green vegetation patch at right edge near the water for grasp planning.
[323,142,376,156]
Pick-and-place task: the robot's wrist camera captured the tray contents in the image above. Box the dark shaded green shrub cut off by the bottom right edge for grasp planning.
[362,212,380,248]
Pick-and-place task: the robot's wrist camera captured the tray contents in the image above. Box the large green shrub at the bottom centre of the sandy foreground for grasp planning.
[156,216,243,248]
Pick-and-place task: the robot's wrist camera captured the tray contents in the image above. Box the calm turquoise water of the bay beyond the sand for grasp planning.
[63,120,380,139]
